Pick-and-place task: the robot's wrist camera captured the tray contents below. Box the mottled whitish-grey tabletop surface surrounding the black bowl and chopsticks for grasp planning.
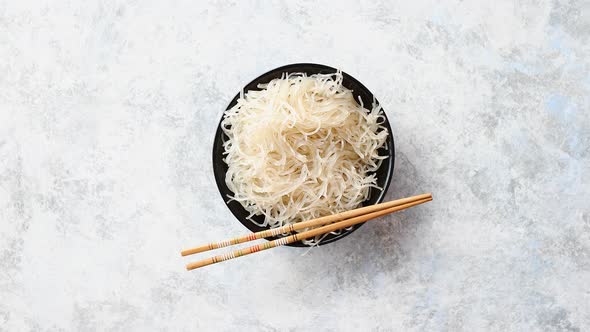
[0,0,590,331]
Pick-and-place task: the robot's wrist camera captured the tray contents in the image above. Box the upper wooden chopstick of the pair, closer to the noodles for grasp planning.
[180,193,432,256]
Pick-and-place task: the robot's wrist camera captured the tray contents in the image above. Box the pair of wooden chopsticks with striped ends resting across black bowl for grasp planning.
[181,193,432,271]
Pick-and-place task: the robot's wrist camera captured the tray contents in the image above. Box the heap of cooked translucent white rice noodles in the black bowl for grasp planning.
[222,72,388,241]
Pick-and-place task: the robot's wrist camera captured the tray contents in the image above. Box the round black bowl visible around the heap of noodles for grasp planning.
[213,63,395,247]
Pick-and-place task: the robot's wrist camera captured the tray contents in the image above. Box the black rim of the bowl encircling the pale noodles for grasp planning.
[212,62,395,248]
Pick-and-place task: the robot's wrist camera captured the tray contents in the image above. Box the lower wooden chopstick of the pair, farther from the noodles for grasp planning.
[186,197,432,271]
